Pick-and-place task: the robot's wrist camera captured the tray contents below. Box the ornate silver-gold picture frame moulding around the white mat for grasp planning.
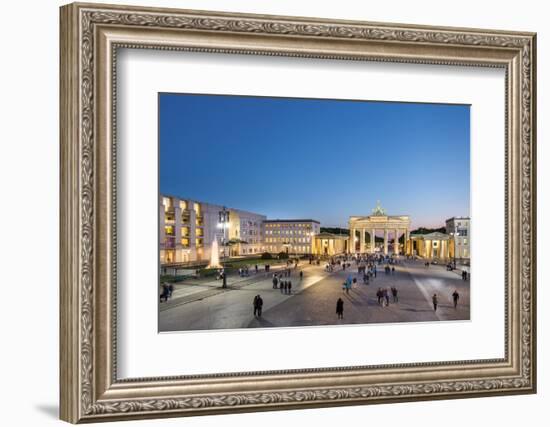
[60,4,536,423]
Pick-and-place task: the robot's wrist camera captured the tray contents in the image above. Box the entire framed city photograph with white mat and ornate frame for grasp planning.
[60,4,536,423]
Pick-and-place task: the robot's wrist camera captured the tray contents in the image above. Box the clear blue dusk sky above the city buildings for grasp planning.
[159,93,470,229]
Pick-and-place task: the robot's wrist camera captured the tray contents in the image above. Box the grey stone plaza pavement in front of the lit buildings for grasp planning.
[159,261,470,331]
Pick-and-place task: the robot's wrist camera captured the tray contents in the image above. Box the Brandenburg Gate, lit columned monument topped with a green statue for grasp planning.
[348,202,411,255]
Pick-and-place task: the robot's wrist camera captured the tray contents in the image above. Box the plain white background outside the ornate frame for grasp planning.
[0,0,550,427]
